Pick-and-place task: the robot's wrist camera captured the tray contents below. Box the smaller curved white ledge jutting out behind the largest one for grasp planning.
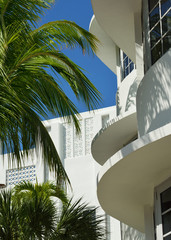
[91,111,137,165]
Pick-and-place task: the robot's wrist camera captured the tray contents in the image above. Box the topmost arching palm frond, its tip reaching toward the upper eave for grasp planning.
[32,20,100,54]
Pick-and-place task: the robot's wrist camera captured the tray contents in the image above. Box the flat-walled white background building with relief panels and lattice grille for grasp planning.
[0,107,120,240]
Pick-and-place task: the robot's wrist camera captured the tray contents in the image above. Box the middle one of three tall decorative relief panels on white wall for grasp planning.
[74,120,83,157]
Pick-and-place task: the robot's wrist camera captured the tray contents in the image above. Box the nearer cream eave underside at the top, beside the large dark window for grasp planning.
[91,0,142,62]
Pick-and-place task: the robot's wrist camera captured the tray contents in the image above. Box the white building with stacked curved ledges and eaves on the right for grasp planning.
[90,0,171,240]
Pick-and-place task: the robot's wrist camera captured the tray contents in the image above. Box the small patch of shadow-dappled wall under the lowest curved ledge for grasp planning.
[121,223,145,240]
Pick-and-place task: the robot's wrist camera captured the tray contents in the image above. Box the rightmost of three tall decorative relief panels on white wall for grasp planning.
[85,118,93,154]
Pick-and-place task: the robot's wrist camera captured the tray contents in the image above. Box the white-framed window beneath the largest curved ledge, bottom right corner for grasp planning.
[155,179,171,240]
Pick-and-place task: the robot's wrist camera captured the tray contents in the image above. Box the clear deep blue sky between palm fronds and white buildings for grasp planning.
[40,0,116,112]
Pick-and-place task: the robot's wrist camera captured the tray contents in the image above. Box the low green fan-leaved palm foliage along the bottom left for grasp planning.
[0,182,105,240]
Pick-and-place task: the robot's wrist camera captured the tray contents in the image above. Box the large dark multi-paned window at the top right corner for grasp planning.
[148,0,171,64]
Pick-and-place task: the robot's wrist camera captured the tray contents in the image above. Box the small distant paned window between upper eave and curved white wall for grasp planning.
[120,50,135,80]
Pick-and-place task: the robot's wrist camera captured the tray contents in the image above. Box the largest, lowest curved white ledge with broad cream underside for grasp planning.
[97,124,171,232]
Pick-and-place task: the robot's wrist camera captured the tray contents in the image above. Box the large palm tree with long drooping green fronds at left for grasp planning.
[0,0,100,182]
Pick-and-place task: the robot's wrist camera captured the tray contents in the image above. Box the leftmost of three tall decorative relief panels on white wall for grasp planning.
[63,123,73,158]
